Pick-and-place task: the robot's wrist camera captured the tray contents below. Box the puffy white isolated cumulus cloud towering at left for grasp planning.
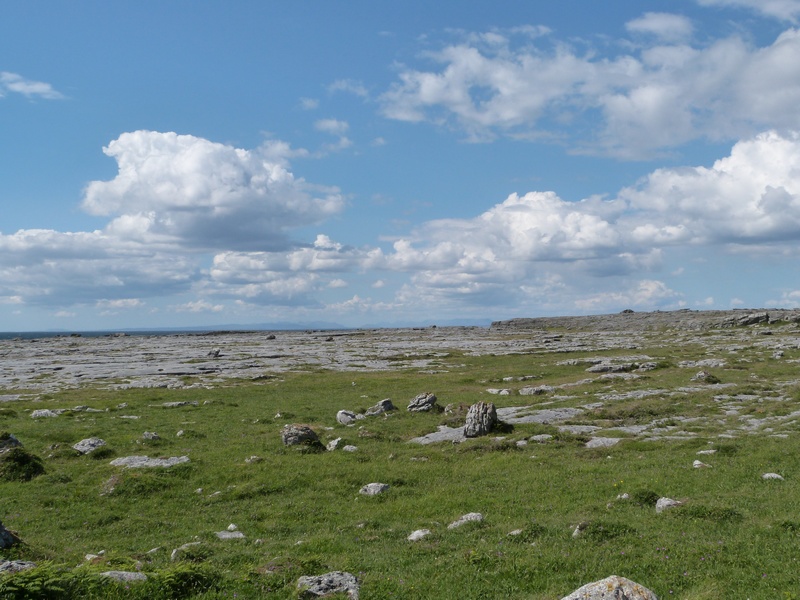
[83,131,343,250]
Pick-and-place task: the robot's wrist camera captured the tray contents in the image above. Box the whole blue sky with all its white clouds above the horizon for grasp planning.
[0,0,800,331]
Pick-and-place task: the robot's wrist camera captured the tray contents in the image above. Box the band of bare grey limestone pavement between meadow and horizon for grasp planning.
[0,310,800,401]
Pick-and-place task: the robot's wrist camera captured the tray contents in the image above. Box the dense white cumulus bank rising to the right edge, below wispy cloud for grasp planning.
[382,131,800,309]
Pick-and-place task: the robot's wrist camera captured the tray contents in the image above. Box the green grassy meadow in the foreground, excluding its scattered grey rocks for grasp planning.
[0,326,800,600]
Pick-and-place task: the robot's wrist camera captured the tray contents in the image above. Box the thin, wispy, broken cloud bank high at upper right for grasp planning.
[382,25,800,158]
